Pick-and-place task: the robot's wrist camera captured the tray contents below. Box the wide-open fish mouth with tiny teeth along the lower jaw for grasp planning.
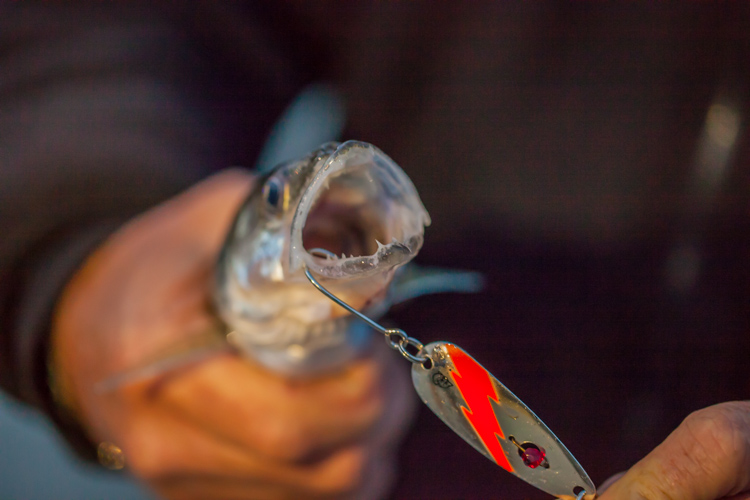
[289,141,430,279]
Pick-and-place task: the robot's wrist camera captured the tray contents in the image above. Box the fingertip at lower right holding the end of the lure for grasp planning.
[599,401,750,500]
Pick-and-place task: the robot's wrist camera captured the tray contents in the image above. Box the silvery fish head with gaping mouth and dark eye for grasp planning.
[216,141,430,372]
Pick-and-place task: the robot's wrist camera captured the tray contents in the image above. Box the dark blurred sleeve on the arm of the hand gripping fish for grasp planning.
[0,2,308,454]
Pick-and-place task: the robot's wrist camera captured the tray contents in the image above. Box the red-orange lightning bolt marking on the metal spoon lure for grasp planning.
[446,344,513,472]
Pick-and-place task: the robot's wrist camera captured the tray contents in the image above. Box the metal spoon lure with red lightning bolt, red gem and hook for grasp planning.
[305,268,596,500]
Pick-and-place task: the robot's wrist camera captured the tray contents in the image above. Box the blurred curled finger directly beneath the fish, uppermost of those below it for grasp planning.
[158,340,400,461]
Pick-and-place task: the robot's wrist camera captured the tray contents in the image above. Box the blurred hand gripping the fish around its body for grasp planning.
[52,171,414,499]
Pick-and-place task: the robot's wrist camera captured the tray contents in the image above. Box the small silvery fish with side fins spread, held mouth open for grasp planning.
[99,141,483,391]
